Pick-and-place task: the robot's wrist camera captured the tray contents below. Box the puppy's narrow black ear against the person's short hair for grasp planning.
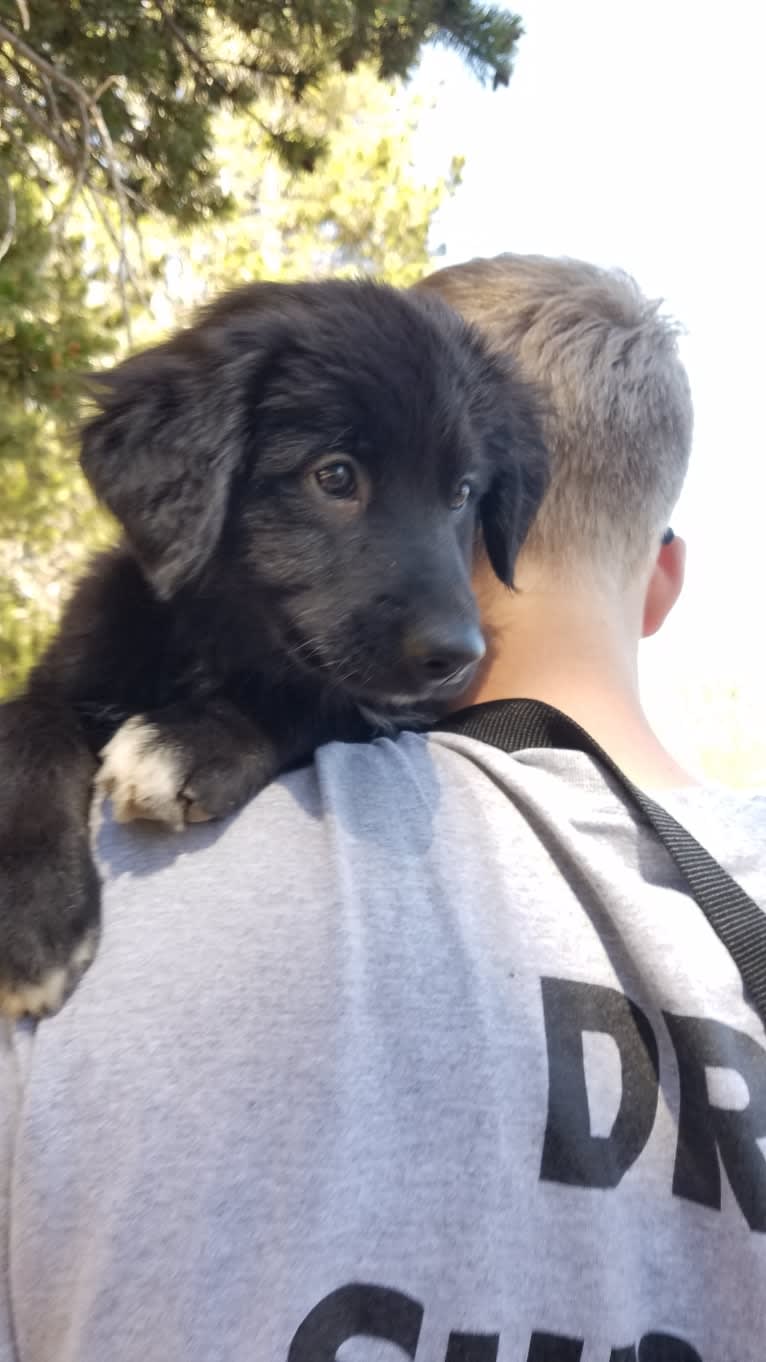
[480,379,549,587]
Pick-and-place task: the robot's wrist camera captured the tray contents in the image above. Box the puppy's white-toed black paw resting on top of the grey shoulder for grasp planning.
[97,699,316,831]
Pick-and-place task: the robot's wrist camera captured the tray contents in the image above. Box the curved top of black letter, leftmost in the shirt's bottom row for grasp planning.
[288,1282,423,1362]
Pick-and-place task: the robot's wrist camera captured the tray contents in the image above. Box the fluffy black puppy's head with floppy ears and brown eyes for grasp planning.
[83,282,547,706]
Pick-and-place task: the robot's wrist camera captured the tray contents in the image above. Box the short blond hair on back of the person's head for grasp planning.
[417,255,692,573]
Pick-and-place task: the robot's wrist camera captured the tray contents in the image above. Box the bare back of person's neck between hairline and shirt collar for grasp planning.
[461,558,695,789]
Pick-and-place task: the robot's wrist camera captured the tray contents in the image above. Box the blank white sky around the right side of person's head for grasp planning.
[418,0,766,782]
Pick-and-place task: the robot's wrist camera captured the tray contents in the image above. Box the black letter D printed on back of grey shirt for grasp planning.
[540,979,658,1188]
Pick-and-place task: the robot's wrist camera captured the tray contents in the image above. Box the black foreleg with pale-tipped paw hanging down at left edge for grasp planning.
[0,695,99,1017]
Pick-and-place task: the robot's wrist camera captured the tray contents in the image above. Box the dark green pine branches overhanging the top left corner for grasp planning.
[0,0,521,225]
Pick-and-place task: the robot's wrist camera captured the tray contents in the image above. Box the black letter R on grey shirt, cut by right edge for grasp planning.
[665,1013,766,1233]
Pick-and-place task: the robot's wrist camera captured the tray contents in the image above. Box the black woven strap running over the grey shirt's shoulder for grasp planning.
[436,700,766,1026]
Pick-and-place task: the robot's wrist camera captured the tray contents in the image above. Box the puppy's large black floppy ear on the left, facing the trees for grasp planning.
[80,331,252,599]
